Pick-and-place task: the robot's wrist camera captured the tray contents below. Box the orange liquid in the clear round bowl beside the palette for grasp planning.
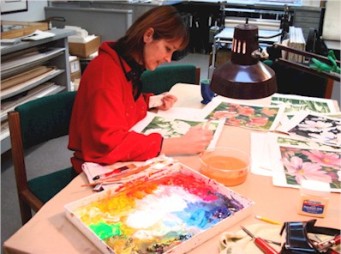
[201,155,248,186]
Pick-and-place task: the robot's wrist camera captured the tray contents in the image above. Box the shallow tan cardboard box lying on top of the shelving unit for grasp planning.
[1,21,49,39]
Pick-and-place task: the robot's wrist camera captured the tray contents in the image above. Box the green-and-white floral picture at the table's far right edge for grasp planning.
[271,94,336,115]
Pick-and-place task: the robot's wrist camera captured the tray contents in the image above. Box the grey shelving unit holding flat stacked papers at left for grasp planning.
[0,29,74,153]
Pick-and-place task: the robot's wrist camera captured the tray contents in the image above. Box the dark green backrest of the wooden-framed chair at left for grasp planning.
[11,92,76,149]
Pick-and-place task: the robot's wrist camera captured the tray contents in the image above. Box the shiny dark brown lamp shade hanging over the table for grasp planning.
[210,23,277,99]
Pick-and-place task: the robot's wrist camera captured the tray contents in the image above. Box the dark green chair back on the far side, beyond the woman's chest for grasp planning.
[141,64,200,94]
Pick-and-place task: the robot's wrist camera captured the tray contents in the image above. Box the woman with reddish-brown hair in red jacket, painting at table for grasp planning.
[68,6,212,172]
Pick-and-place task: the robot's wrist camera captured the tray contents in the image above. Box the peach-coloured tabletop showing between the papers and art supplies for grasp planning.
[3,84,341,254]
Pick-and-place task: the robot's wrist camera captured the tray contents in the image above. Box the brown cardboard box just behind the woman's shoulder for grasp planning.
[69,36,101,58]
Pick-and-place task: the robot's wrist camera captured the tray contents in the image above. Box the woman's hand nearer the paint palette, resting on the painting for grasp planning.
[161,125,213,155]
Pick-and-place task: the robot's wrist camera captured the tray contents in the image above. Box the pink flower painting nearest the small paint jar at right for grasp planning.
[280,146,341,190]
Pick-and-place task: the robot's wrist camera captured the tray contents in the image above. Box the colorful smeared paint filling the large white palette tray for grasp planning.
[66,161,252,254]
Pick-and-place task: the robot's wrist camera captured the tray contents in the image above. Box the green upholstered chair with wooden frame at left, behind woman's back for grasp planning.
[8,92,77,224]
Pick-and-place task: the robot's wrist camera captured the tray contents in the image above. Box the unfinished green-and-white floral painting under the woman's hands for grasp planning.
[132,112,224,149]
